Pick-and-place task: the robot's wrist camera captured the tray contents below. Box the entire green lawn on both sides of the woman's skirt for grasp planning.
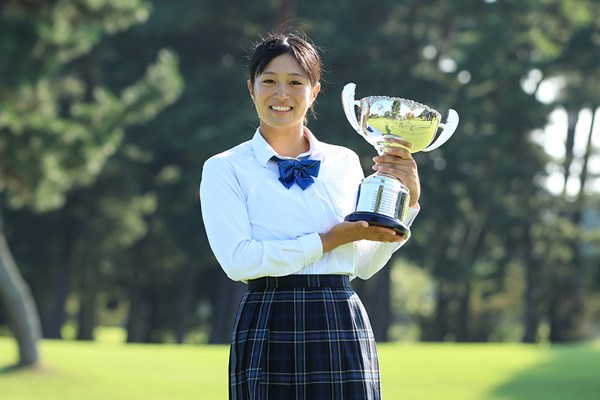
[0,338,600,400]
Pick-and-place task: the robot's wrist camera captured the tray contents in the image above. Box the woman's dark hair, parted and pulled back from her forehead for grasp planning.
[248,32,322,85]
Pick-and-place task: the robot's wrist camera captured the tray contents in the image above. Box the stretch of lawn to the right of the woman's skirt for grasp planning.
[378,344,600,400]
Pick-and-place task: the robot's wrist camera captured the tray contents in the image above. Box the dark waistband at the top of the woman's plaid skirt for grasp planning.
[248,275,350,290]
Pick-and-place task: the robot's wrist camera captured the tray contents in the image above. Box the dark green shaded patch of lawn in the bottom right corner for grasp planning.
[491,345,600,400]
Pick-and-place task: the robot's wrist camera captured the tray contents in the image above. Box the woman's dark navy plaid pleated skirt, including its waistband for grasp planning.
[229,275,381,400]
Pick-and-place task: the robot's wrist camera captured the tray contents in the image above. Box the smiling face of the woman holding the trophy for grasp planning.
[248,54,321,132]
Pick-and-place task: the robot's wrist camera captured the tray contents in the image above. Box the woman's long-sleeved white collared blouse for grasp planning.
[200,129,418,281]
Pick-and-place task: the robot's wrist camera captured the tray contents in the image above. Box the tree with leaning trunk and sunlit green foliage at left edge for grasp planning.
[0,0,182,366]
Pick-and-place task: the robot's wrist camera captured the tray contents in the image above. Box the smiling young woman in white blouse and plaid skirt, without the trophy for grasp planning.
[200,28,420,400]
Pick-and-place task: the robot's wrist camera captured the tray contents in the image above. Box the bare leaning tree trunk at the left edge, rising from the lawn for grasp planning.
[0,210,41,367]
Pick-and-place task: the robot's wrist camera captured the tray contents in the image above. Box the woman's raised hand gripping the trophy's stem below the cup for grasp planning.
[373,139,421,207]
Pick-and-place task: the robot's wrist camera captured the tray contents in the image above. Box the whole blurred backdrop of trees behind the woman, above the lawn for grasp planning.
[0,0,600,364]
